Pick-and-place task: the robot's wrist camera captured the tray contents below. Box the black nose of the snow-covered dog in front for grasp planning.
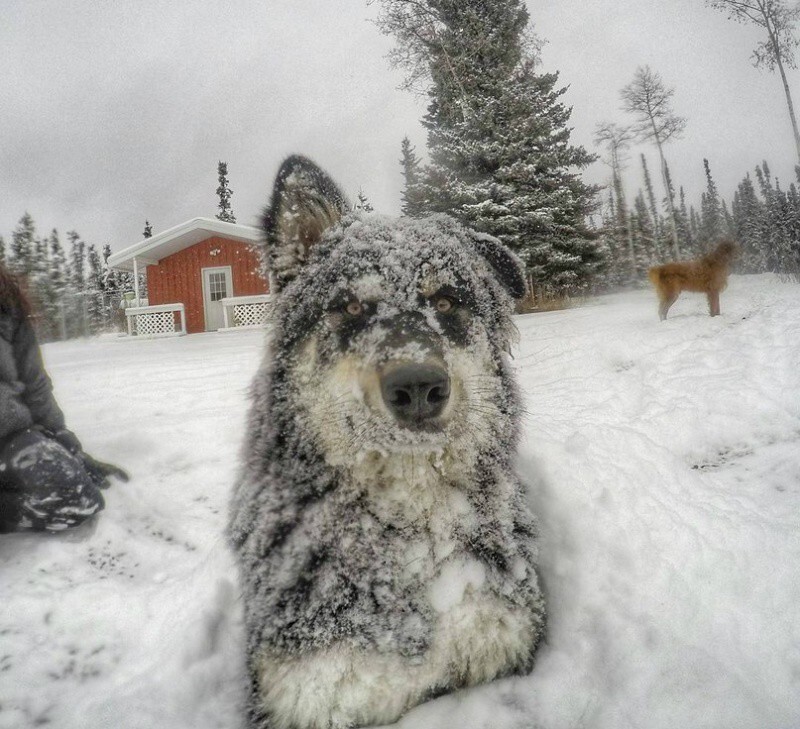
[381,364,450,425]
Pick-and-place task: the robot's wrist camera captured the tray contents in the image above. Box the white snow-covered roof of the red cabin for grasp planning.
[108,218,263,271]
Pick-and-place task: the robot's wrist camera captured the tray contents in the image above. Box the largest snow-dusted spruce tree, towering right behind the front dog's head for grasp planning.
[379,0,601,292]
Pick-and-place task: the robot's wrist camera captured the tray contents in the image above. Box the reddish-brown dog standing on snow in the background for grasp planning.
[647,240,739,321]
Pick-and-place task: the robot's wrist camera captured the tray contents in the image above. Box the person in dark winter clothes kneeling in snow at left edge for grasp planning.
[0,264,128,533]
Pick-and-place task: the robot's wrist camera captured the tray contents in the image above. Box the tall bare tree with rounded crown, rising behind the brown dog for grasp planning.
[620,66,686,258]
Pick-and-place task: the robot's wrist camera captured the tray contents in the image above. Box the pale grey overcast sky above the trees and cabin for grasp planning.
[0,0,800,250]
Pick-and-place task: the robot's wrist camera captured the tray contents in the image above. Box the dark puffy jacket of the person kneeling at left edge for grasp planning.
[0,311,64,442]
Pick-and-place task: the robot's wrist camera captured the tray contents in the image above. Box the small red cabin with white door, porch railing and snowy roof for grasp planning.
[108,218,269,336]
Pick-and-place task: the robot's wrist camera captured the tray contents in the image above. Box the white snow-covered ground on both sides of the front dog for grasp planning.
[0,276,800,729]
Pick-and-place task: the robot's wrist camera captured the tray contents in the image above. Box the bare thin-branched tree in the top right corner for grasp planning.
[706,0,800,162]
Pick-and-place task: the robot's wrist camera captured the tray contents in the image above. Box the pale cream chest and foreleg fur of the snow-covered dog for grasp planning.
[257,454,539,729]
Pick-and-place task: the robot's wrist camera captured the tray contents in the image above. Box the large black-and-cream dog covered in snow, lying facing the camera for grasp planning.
[229,157,544,729]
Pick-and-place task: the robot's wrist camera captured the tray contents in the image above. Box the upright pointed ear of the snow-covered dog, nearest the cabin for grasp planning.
[262,155,350,291]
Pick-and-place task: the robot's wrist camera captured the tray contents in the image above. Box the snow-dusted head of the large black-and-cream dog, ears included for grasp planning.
[266,158,524,467]
